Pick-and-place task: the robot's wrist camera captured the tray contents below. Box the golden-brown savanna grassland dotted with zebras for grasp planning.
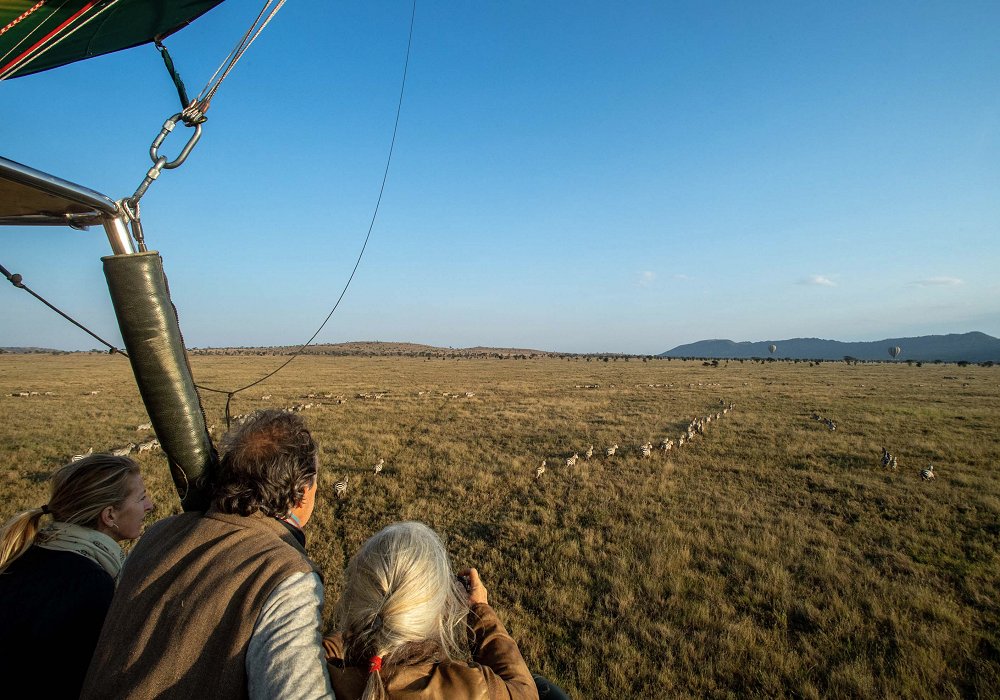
[0,355,1000,698]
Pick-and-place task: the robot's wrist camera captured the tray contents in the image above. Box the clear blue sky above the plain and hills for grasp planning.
[0,0,1000,353]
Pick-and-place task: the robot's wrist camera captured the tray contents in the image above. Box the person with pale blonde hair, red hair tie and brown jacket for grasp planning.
[324,522,538,700]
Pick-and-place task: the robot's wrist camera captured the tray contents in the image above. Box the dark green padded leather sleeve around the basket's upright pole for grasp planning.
[101,251,217,510]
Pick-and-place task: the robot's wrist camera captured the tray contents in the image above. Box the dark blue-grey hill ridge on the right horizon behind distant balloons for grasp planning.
[660,332,1000,362]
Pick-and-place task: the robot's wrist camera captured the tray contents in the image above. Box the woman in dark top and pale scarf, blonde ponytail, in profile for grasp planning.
[0,454,153,698]
